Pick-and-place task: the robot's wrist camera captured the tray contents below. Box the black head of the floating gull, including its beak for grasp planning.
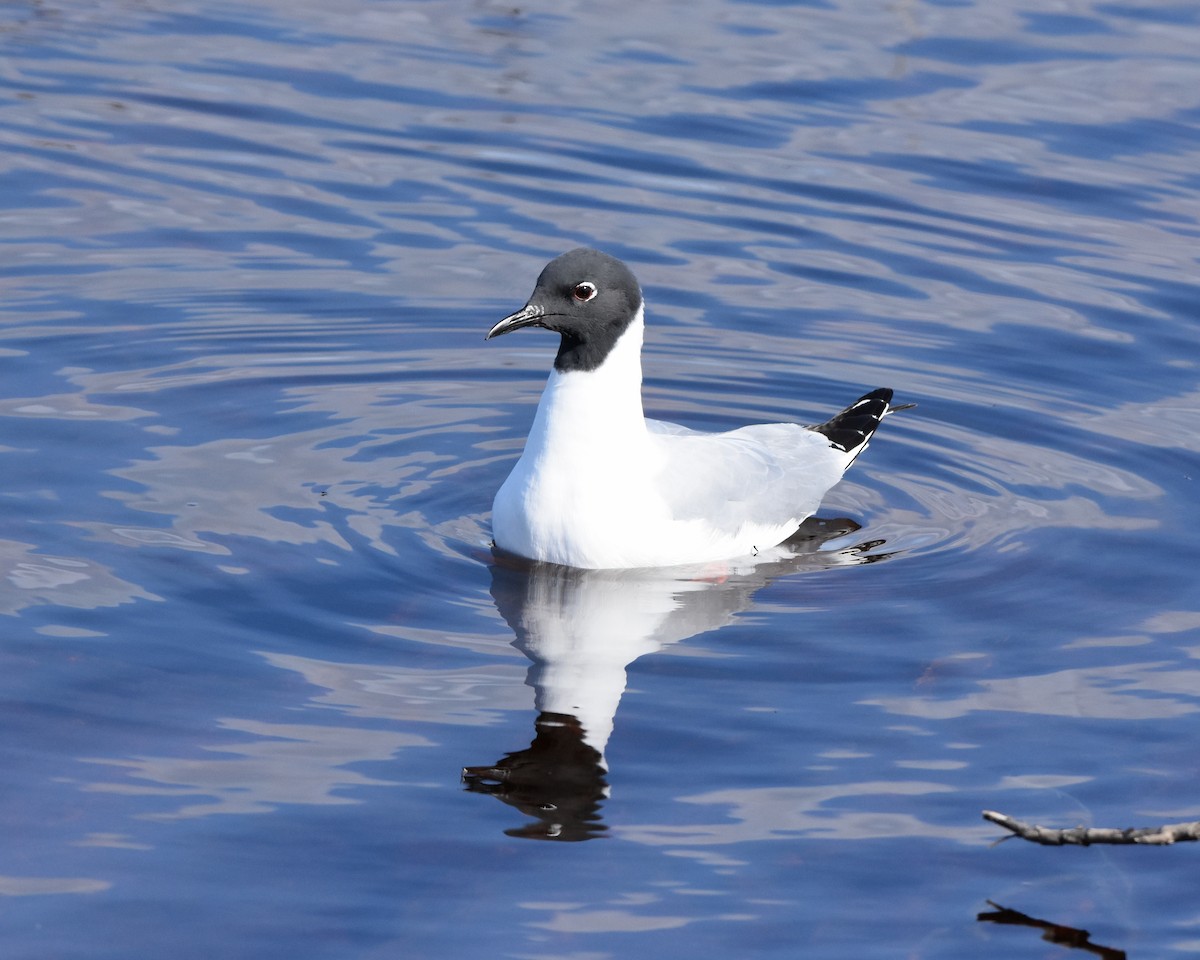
[485,247,642,373]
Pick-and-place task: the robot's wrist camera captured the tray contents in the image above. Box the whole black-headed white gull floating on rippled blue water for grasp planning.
[486,247,911,570]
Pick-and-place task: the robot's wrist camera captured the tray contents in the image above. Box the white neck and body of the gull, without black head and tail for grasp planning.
[492,307,865,569]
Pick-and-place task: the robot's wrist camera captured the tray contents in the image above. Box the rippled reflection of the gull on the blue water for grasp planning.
[462,517,889,840]
